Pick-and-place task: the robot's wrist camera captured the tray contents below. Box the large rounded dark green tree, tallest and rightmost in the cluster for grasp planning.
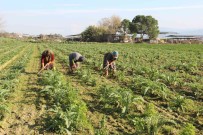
[130,15,159,40]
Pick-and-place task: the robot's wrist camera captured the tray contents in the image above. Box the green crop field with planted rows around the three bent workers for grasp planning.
[0,38,203,135]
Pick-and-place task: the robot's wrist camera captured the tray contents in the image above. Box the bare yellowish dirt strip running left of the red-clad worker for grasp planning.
[0,46,44,135]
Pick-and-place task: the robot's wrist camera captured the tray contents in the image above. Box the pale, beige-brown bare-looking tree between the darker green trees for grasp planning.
[99,15,121,34]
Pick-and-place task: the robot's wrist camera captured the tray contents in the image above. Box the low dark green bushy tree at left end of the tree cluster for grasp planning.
[81,26,105,42]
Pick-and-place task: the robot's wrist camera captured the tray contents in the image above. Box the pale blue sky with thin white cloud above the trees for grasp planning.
[0,0,203,36]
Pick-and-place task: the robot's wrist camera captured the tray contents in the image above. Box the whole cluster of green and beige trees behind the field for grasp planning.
[81,15,159,42]
